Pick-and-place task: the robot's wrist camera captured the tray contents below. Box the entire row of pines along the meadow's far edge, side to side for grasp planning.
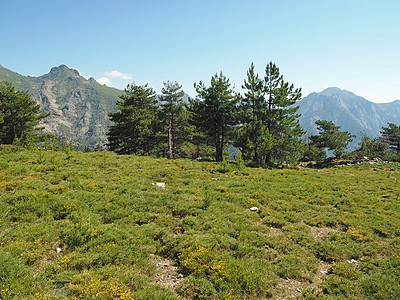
[0,62,400,167]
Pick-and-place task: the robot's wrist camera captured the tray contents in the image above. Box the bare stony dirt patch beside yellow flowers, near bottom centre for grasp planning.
[150,254,183,289]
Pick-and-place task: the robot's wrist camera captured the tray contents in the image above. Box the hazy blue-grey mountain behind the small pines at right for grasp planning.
[296,87,400,145]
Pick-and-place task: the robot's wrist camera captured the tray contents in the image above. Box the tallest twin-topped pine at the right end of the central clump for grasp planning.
[235,62,305,166]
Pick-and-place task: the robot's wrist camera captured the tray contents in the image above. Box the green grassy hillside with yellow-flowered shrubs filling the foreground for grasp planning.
[0,146,400,299]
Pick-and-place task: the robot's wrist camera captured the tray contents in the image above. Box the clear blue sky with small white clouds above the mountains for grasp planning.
[0,0,400,102]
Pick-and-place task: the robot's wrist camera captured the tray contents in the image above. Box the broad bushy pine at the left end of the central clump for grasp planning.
[107,83,159,155]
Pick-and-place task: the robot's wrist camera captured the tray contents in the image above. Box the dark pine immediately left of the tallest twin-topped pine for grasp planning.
[189,72,238,161]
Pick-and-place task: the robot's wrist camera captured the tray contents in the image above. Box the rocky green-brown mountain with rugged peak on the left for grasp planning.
[0,65,123,148]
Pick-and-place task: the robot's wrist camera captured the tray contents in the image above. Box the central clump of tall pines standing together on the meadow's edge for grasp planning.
[107,62,305,166]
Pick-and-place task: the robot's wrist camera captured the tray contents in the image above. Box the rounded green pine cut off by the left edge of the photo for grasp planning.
[0,81,47,144]
